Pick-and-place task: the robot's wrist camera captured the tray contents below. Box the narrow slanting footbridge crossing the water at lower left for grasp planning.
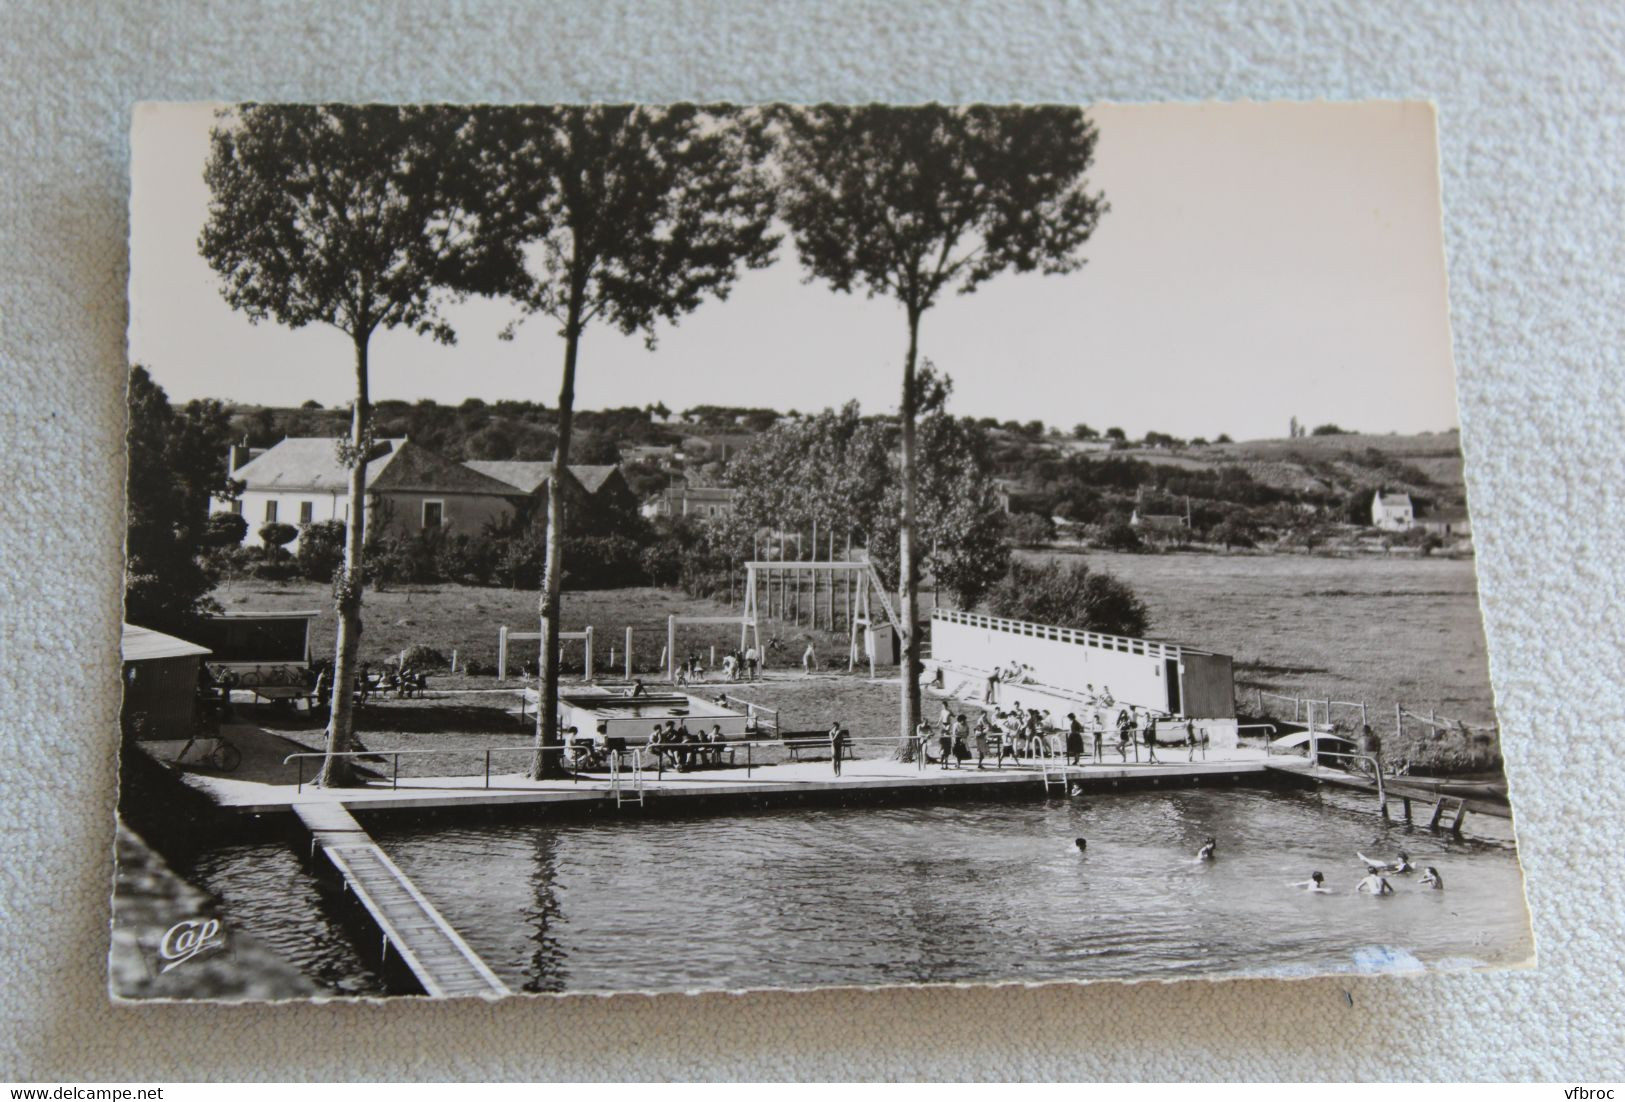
[293,803,509,998]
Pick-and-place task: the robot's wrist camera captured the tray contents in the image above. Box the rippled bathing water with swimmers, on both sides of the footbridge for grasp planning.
[181,790,1532,991]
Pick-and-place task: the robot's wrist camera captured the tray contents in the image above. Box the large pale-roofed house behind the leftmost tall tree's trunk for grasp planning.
[213,437,525,549]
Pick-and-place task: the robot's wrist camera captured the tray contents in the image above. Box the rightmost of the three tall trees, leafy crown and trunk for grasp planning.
[780,106,1107,748]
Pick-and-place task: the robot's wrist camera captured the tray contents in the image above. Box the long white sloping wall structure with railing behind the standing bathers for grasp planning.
[926,608,1237,748]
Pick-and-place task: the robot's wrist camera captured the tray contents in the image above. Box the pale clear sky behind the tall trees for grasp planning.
[130,102,1458,439]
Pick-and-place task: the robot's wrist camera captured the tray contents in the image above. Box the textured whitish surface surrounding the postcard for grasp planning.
[0,0,1625,1081]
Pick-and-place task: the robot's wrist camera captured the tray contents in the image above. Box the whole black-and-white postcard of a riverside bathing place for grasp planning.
[107,101,1536,1003]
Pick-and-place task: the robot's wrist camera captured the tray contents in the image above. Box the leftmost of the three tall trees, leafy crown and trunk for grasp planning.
[198,104,468,785]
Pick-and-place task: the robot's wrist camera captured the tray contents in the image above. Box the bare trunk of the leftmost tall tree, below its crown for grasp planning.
[315,333,372,788]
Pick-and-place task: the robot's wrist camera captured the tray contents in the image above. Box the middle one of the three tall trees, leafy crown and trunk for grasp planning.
[468,106,778,777]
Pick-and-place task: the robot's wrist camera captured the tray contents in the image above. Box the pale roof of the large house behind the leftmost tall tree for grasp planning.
[232,436,514,496]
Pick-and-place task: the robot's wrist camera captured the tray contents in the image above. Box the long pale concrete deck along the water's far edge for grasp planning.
[143,733,1308,814]
